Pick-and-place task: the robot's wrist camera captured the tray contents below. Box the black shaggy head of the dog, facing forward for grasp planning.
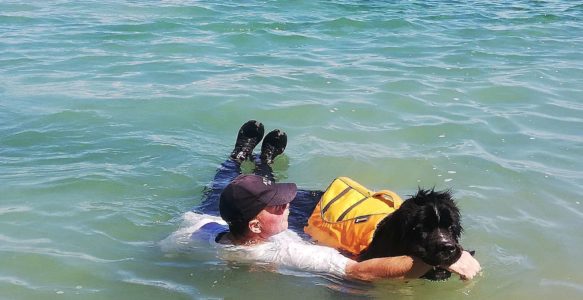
[399,189,463,266]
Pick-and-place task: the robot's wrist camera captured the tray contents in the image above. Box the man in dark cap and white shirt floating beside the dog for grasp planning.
[192,121,480,281]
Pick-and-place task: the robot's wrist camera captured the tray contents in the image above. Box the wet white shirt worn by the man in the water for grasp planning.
[162,212,350,276]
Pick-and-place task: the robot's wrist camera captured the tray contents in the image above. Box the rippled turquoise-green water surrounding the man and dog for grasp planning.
[0,0,583,299]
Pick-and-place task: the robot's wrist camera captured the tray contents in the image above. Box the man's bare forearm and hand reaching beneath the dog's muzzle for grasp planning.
[345,251,481,281]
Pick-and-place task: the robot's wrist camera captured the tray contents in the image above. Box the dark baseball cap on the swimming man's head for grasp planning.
[219,174,297,224]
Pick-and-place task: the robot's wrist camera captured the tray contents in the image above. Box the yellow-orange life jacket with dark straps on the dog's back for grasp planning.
[304,177,403,255]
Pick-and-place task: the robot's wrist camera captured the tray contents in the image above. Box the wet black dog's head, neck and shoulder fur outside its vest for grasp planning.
[358,188,463,280]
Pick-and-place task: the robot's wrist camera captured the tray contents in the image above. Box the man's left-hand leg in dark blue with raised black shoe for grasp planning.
[195,120,264,215]
